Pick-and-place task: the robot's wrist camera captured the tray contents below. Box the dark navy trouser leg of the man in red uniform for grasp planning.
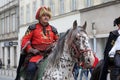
[25,62,37,80]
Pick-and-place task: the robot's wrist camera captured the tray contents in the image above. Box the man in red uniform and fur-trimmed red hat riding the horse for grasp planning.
[15,7,58,80]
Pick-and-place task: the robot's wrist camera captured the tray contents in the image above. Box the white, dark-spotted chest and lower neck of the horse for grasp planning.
[42,43,74,80]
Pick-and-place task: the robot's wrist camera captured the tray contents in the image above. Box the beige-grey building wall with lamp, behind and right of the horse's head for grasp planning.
[80,0,120,59]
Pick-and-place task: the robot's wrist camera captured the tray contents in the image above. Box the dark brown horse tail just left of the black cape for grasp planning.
[90,60,103,80]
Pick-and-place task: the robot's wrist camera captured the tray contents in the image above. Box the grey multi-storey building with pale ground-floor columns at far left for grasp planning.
[0,0,19,68]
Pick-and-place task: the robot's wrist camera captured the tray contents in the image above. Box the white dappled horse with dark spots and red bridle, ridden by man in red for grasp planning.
[37,21,94,80]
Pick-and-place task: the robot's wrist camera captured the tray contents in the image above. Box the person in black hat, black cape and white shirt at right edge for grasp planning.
[99,17,120,80]
